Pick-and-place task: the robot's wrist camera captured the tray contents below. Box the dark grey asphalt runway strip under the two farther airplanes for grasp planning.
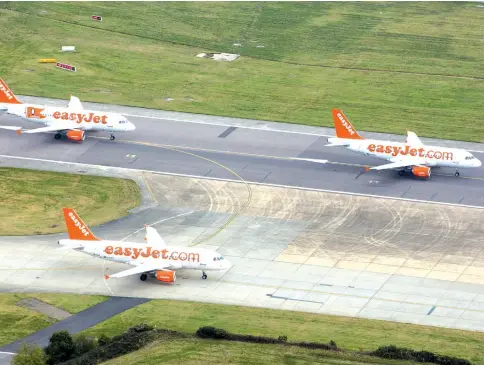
[0,111,484,206]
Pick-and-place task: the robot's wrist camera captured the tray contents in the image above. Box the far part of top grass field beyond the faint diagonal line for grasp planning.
[4,2,484,77]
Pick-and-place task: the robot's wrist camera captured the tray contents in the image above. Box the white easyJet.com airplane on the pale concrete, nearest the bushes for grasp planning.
[57,208,232,283]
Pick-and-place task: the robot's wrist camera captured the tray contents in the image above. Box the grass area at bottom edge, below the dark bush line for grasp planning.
[102,338,415,365]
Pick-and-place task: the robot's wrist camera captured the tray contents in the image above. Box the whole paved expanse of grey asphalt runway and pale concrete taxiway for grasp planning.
[0,97,484,331]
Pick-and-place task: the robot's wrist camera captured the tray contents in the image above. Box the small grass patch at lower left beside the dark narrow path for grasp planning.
[0,293,107,346]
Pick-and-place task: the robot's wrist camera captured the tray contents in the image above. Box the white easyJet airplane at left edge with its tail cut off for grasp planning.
[0,79,136,141]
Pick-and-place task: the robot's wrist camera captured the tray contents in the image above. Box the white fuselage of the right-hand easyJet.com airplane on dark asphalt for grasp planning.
[328,138,480,168]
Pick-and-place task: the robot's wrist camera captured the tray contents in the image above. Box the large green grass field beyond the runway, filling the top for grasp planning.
[0,2,484,141]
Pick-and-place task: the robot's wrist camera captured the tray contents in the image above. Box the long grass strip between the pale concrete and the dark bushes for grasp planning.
[84,300,484,364]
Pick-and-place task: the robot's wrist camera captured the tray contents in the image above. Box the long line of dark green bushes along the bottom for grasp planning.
[12,324,472,365]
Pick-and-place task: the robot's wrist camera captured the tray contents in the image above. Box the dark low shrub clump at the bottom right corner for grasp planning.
[370,345,471,365]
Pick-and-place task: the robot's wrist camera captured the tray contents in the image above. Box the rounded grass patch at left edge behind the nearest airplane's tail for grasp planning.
[0,168,141,236]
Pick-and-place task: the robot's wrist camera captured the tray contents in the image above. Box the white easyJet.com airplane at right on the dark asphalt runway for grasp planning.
[326,109,482,178]
